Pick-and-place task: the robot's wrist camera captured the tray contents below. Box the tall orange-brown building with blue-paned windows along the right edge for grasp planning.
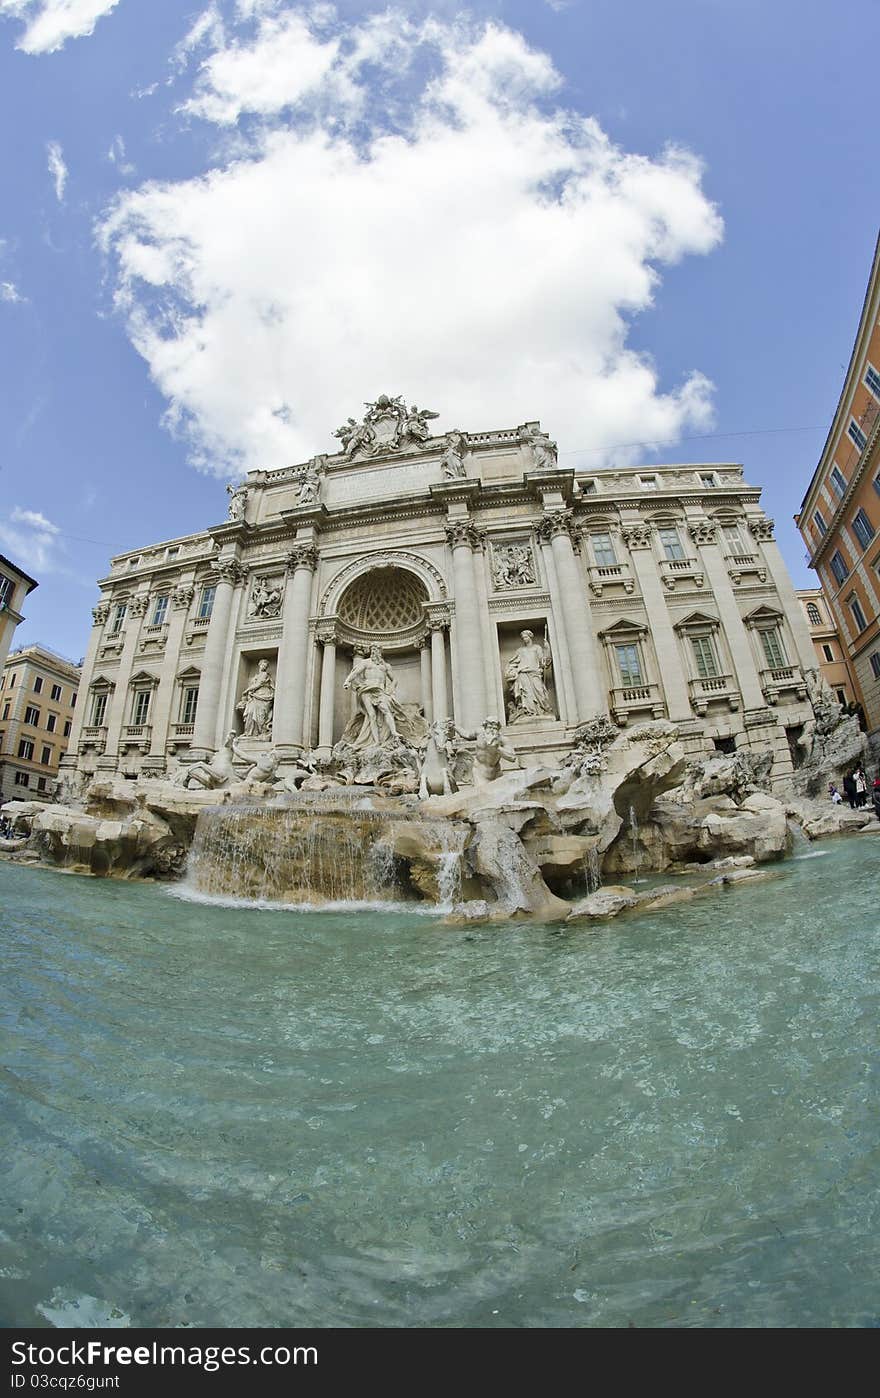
[795,232,880,747]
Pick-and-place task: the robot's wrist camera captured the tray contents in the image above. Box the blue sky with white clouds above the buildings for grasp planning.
[0,0,879,658]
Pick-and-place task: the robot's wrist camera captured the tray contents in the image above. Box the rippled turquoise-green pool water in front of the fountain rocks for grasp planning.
[0,836,880,1327]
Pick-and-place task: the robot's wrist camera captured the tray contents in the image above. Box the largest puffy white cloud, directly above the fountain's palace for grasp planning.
[99,3,722,474]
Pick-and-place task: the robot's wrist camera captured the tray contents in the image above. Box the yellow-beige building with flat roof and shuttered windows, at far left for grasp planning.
[0,646,81,801]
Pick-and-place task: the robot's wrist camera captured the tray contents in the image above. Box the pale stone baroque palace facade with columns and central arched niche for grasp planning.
[63,396,816,777]
